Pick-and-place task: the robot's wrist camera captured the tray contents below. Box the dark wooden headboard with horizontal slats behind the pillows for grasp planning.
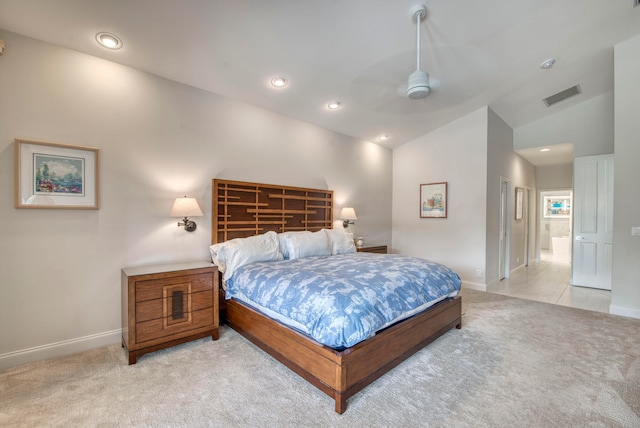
[211,178,333,244]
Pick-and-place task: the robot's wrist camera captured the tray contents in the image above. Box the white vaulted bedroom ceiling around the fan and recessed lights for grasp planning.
[0,0,640,165]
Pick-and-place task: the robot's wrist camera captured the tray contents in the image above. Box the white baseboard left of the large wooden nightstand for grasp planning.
[0,329,122,370]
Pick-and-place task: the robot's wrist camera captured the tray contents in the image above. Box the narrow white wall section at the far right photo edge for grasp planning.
[610,36,640,318]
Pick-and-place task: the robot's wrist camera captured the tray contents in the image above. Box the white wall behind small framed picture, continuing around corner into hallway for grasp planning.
[393,107,535,290]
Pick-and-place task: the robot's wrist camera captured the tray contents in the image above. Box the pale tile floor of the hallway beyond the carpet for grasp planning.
[487,252,611,313]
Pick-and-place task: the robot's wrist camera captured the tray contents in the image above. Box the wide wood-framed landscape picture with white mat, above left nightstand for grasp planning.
[14,138,100,210]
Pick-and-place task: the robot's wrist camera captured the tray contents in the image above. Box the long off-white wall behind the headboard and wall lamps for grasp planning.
[0,30,392,369]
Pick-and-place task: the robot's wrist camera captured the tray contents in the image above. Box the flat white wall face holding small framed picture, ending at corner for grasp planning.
[393,107,488,284]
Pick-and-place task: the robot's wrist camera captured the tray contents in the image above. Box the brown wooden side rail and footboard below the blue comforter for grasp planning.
[226,296,462,413]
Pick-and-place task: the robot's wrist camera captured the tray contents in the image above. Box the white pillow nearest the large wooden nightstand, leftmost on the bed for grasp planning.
[209,231,283,281]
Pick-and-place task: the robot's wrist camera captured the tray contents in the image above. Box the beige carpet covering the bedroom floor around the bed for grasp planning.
[0,290,640,427]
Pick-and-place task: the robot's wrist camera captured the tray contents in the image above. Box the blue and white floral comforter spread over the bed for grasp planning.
[226,252,461,349]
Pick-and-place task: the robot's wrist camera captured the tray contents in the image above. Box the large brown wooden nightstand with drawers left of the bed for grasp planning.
[122,261,218,364]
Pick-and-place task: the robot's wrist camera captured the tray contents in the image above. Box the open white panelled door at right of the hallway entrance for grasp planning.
[571,155,613,290]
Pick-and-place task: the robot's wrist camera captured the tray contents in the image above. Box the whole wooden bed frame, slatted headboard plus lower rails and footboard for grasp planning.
[212,179,462,413]
